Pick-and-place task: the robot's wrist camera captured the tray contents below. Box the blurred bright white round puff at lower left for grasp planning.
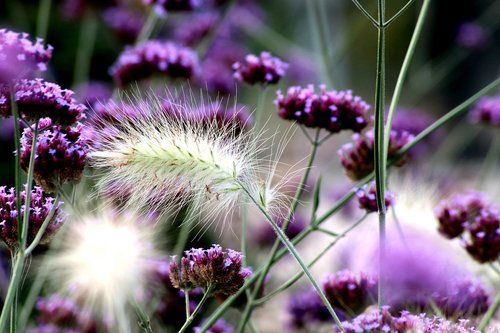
[47,209,161,331]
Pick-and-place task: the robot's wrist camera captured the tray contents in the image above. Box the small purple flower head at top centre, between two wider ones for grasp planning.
[233,52,288,85]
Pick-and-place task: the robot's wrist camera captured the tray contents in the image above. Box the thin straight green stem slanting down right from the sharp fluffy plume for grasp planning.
[240,184,344,331]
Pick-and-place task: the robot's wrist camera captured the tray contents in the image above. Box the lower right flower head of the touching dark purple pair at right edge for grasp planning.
[465,208,500,263]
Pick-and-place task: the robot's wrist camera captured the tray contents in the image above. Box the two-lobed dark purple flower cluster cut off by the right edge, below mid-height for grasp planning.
[435,192,500,263]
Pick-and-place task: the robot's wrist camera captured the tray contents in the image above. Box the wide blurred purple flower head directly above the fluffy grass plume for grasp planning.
[110,40,199,87]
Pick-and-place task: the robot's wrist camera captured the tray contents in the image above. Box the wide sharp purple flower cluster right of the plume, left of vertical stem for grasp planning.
[275,85,371,133]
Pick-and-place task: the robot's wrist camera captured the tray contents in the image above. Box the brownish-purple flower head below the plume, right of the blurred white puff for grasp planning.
[170,245,252,295]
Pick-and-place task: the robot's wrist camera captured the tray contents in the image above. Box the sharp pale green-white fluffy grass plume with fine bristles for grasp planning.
[89,91,288,220]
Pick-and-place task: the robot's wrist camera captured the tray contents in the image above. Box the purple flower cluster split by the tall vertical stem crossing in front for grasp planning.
[337,129,413,180]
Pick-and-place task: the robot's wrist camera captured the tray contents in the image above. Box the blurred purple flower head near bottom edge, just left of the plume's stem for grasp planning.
[287,288,342,329]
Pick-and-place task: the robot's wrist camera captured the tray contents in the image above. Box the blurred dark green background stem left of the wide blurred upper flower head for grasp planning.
[73,12,98,86]
